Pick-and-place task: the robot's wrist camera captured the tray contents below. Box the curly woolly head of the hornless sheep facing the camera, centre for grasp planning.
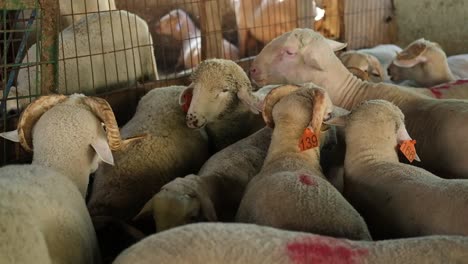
[179,59,259,128]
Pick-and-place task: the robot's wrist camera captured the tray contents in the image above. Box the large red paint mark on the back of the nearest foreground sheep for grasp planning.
[286,236,368,264]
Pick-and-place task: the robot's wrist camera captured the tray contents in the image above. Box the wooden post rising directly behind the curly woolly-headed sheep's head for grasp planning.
[200,0,223,60]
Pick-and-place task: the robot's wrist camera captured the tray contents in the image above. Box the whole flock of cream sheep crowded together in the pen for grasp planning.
[0,0,468,264]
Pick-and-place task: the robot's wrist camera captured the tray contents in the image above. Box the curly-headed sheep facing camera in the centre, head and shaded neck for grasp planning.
[179,59,276,150]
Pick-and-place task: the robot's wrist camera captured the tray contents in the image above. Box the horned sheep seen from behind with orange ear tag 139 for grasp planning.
[236,85,371,240]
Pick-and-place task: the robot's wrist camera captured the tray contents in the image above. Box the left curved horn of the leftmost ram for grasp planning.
[17,94,68,152]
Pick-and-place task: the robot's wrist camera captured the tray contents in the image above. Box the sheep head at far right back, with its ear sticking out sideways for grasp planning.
[388,38,453,87]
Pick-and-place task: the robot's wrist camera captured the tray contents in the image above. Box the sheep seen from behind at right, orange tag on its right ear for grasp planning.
[329,100,468,239]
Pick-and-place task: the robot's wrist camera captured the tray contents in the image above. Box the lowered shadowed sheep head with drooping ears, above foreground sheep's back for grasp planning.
[135,175,217,232]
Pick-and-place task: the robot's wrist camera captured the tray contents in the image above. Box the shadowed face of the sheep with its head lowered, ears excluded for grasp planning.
[153,189,201,232]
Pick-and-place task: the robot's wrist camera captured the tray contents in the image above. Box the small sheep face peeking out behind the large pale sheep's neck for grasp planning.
[339,50,386,83]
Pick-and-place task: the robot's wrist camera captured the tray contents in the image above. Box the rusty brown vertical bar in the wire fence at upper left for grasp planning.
[40,0,60,95]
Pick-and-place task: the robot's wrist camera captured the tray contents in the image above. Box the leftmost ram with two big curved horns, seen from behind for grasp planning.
[0,95,135,263]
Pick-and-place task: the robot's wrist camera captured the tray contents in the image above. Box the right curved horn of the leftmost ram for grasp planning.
[83,97,124,150]
